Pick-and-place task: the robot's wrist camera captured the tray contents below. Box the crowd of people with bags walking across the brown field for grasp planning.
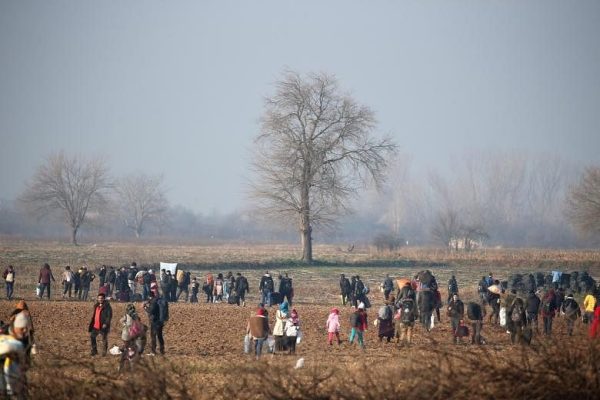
[0,262,600,395]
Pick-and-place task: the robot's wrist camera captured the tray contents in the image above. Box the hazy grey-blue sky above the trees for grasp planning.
[0,0,600,213]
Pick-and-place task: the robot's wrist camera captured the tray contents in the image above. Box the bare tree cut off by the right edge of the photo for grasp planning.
[567,167,600,238]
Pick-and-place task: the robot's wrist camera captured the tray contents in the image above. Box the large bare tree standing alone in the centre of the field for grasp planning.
[253,71,396,262]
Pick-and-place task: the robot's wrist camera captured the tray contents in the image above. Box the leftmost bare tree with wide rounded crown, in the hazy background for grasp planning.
[21,151,110,244]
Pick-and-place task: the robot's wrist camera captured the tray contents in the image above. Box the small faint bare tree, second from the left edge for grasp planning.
[115,173,168,238]
